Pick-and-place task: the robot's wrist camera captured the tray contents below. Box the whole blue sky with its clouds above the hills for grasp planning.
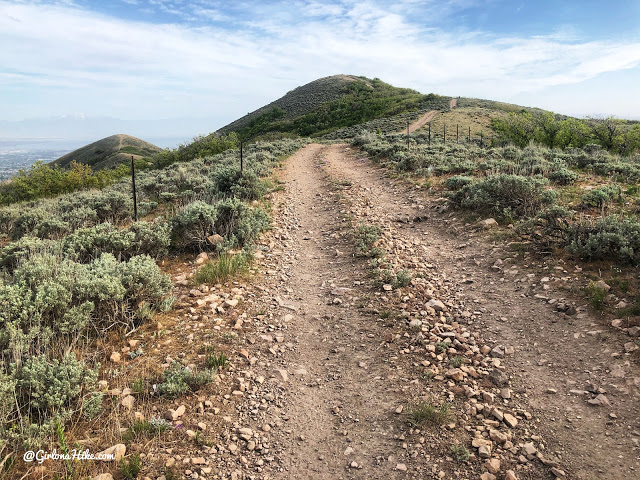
[0,0,640,141]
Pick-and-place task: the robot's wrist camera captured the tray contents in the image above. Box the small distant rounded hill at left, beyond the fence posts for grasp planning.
[51,134,162,171]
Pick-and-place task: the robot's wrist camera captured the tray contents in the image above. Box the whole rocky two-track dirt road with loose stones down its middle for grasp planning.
[142,144,640,480]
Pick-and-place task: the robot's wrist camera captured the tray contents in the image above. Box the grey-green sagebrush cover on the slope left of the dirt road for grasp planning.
[0,135,302,450]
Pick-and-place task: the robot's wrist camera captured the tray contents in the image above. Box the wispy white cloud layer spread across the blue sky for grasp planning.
[0,0,640,128]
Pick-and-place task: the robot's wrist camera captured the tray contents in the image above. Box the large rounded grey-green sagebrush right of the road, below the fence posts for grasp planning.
[451,174,555,217]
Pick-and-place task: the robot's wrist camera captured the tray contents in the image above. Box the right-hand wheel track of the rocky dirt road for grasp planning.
[316,146,640,479]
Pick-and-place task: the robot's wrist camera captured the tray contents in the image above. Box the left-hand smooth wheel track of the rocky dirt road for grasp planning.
[270,145,424,479]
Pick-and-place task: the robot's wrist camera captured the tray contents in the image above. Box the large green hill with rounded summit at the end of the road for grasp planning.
[218,75,449,138]
